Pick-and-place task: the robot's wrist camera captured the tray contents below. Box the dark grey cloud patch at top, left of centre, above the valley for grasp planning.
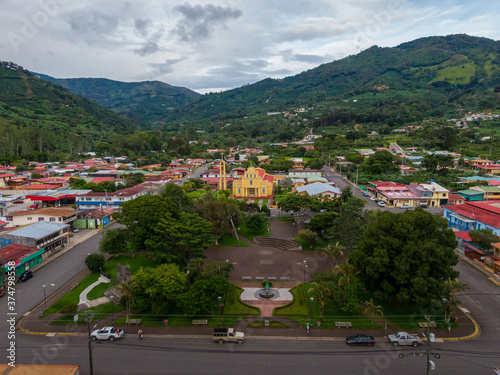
[173,3,243,42]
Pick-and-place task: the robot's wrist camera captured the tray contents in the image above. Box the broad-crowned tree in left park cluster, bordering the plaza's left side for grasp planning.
[145,212,215,266]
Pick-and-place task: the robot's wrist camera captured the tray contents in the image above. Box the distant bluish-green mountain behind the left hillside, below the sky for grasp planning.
[37,74,201,126]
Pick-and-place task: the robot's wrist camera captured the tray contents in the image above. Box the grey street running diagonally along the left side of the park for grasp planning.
[0,224,117,341]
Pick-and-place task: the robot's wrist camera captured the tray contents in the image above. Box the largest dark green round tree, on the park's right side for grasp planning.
[349,209,458,307]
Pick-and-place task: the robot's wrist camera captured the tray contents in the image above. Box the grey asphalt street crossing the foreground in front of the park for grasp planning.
[4,330,497,375]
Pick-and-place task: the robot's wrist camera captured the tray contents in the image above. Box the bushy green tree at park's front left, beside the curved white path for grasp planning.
[132,264,187,314]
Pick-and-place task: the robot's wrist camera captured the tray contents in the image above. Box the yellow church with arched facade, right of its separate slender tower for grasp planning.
[233,167,273,199]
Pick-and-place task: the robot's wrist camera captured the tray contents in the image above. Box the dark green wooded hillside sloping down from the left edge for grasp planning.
[0,62,137,160]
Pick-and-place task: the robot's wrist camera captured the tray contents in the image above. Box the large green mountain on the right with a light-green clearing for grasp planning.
[168,35,500,126]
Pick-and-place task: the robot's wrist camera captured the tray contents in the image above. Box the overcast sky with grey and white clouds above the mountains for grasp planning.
[0,0,500,93]
